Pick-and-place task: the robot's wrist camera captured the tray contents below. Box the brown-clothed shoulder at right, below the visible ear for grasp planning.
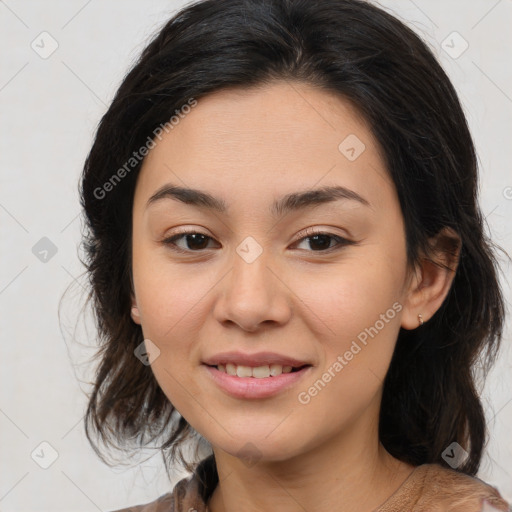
[385,464,511,512]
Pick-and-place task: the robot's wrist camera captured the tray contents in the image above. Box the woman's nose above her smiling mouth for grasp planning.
[213,247,293,332]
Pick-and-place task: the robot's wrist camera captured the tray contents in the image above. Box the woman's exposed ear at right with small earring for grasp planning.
[401,227,461,330]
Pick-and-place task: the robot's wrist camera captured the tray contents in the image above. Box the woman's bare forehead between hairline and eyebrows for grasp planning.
[136,82,396,214]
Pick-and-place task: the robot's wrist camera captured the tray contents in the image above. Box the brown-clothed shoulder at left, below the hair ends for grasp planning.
[106,476,206,512]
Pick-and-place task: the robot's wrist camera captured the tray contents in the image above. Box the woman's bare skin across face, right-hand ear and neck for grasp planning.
[131,82,460,512]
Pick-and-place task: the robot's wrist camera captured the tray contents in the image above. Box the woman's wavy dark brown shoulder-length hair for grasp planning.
[80,0,504,475]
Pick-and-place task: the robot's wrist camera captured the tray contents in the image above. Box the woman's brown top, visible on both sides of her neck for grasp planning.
[110,456,512,512]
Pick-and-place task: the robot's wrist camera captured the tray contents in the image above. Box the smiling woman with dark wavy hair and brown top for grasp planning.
[81,0,508,512]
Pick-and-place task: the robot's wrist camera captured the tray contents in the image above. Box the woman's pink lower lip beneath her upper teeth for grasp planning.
[203,365,312,398]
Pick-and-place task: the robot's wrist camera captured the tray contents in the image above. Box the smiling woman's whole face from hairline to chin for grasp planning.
[132,83,416,460]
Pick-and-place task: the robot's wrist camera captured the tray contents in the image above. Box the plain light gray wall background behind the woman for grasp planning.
[0,0,512,512]
